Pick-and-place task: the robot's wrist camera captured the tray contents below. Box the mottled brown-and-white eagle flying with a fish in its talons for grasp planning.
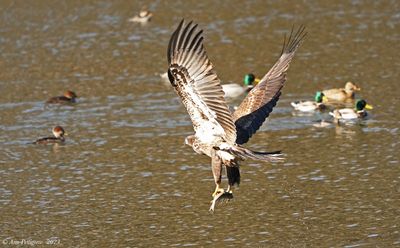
[167,20,306,211]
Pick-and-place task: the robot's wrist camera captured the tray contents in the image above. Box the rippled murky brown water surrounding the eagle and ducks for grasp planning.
[0,0,400,247]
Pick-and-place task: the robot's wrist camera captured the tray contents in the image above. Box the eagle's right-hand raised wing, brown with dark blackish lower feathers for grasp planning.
[233,26,306,144]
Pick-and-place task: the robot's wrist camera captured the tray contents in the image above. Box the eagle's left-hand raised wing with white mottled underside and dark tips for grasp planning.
[167,20,236,144]
